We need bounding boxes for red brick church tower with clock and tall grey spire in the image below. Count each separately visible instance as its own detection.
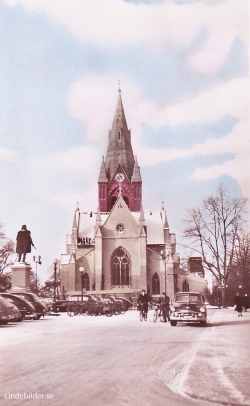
[98,88,142,212]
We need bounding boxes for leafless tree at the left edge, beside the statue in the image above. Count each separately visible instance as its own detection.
[0,224,15,290]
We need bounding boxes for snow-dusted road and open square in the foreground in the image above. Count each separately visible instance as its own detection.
[0,309,250,406]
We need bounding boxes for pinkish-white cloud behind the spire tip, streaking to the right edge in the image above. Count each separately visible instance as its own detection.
[69,75,250,200]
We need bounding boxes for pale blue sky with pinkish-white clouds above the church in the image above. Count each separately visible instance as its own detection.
[0,0,250,281]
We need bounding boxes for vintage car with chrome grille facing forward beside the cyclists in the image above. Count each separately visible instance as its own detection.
[169,292,207,326]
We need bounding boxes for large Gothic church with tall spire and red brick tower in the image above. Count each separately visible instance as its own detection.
[60,89,188,299]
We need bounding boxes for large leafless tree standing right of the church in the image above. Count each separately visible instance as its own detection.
[184,185,246,306]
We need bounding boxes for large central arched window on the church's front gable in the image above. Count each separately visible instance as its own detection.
[111,247,130,286]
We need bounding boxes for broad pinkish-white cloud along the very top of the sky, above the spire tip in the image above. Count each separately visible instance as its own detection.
[3,0,248,75]
